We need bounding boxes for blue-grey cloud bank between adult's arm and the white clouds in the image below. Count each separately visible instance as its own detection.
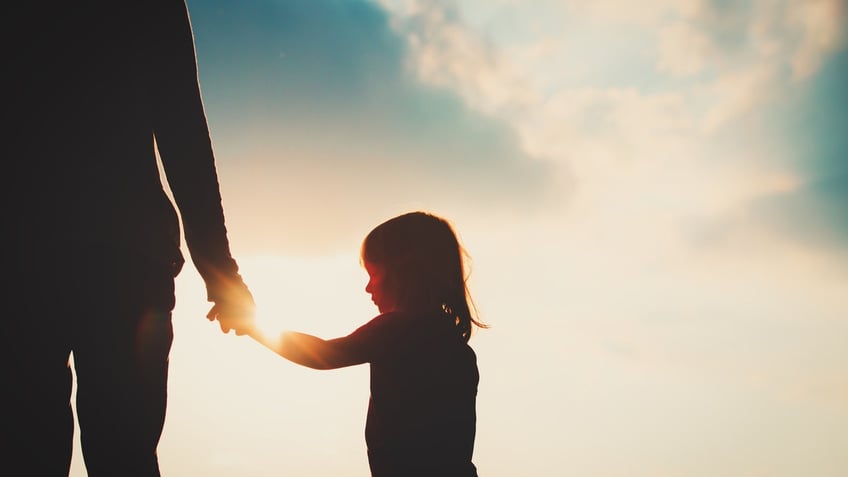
[189,0,561,253]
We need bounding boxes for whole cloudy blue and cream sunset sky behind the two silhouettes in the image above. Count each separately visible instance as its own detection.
[72,0,848,477]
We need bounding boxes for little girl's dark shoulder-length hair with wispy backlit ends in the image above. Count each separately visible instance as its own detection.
[360,212,488,341]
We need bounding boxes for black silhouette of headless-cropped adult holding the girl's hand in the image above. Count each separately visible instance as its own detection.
[2,0,254,477]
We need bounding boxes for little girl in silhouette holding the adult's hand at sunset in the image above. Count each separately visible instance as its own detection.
[245,212,487,477]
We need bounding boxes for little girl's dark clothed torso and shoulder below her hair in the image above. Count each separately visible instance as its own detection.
[332,311,480,477]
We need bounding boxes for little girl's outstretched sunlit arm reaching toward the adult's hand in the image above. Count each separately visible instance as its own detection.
[248,331,364,369]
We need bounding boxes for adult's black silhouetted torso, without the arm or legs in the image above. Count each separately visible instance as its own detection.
[10,0,184,256]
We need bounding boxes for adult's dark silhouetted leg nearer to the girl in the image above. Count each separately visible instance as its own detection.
[74,260,174,477]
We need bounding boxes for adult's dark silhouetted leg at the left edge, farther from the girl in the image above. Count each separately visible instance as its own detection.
[0,253,74,477]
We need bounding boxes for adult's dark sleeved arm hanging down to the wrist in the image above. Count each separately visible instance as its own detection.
[145,0,244,302]
